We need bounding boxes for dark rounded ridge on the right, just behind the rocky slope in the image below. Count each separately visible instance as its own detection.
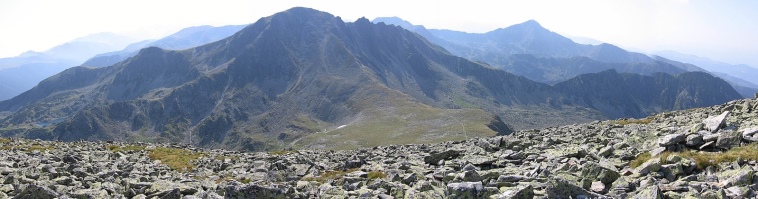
[555,70,741,118]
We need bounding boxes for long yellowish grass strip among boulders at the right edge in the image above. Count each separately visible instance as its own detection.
[629,144,758,169]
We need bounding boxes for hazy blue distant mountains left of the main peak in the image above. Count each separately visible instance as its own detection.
[0,25,244,100]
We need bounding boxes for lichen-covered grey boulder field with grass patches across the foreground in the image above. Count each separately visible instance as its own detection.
[0,96,758,198]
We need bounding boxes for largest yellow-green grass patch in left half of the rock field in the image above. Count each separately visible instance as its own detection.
[148,147,203,171]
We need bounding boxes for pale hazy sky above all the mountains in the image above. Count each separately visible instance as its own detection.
[0,0,758,66]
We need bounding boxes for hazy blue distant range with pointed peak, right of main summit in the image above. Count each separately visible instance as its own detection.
[373,17,758,97]
